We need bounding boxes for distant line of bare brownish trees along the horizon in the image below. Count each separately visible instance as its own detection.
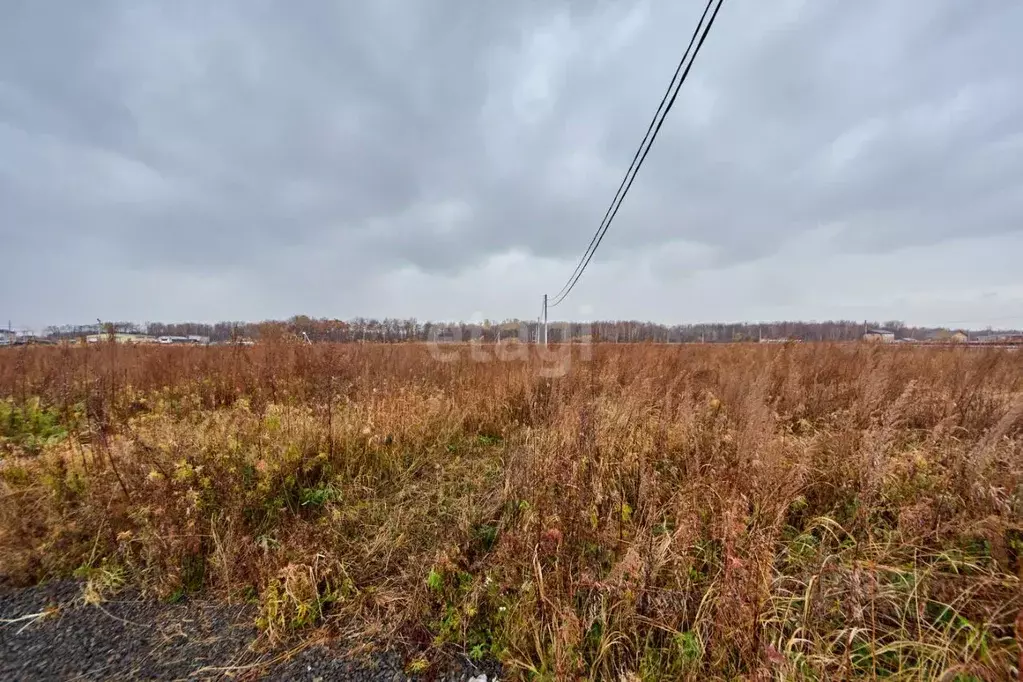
[36,315,1018,344]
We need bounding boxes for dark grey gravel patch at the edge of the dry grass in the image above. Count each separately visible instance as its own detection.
[0,582,496,682]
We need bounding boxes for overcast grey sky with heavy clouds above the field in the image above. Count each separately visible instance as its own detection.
[0,0,1023,327]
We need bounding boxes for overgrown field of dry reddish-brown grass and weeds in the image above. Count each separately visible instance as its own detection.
[0,343,1023,682]
